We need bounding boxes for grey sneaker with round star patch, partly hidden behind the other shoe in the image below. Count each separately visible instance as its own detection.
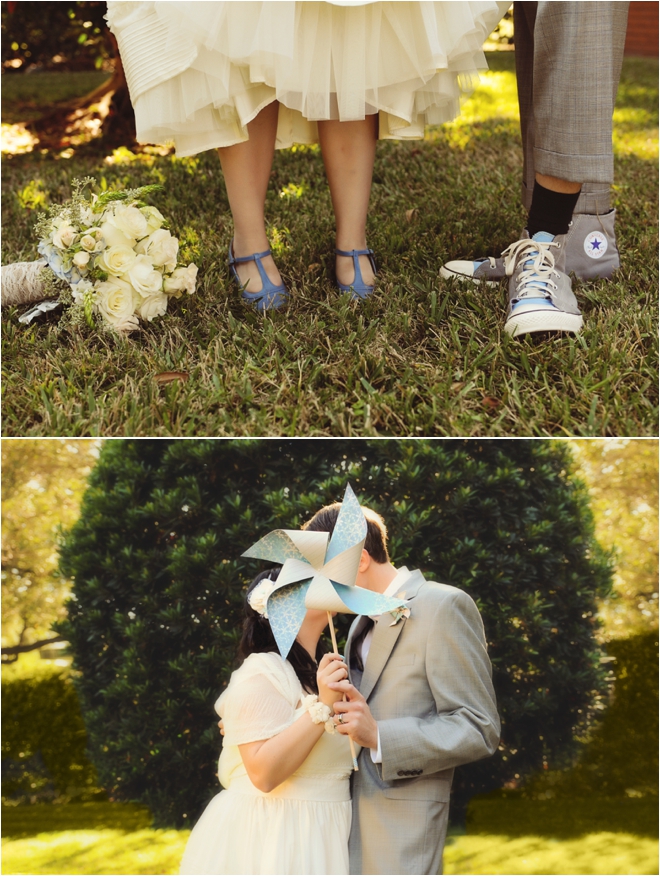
[440,210,620,286]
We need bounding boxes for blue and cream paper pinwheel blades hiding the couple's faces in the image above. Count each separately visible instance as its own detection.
[243,485,405,659]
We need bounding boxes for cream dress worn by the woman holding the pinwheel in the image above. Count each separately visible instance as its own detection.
[180,653,351,876]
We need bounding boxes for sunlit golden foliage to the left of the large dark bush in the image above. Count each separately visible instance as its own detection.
[2,438,98,646]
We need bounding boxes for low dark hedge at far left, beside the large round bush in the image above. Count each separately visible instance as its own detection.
[2,666,97,802]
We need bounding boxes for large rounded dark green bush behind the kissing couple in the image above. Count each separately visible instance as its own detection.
[59,439,611,825]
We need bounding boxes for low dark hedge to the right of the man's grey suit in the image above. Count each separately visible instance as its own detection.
[466,630,658,824]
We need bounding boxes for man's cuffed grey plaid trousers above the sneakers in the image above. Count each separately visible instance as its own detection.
[513,2,629,213]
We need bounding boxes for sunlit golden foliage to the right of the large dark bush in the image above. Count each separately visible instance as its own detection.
[571,439,658,638]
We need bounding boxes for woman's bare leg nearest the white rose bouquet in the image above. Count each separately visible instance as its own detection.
[218,100,282,292]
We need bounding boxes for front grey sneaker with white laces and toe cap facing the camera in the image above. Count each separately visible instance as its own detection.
[502,231,582,338]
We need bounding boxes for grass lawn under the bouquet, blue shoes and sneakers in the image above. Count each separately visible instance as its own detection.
[2,53,658,436]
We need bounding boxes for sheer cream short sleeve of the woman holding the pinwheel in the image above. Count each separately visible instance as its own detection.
[216,654,299,745]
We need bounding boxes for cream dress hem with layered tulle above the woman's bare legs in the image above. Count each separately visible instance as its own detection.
[107,0,509,156]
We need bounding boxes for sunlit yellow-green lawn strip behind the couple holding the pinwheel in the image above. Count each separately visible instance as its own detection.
[2,801,658,876]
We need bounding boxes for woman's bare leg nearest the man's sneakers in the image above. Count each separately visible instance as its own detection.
[318,115,378,286]
